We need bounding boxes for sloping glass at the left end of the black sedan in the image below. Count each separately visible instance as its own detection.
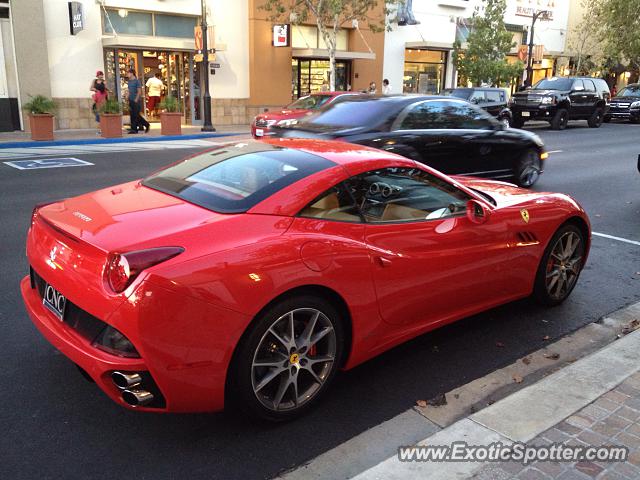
[298,98,400,127]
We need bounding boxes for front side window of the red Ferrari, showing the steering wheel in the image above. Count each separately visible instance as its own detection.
[348,167,469,223]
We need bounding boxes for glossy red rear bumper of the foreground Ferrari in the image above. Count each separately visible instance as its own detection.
[20,276,244,412]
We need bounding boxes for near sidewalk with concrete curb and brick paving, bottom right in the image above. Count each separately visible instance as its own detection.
[281,303,640,480]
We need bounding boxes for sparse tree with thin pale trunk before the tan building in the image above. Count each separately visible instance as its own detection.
[261,0,398,92]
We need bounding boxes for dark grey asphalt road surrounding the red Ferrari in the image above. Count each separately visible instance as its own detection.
[0,122,640,479]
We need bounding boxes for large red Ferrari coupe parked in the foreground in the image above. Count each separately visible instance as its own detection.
[21,139,590,420]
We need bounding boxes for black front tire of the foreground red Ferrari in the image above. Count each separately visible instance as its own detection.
[533,223,586,306]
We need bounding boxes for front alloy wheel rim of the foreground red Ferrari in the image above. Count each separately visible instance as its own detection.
[545,231,584,300]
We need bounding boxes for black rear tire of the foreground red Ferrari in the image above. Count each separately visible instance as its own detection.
[227,295,345,422]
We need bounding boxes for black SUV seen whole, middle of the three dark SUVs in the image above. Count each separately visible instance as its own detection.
[510,77,611,130]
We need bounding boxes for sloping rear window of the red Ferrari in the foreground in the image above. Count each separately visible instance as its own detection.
[142,143,335,213]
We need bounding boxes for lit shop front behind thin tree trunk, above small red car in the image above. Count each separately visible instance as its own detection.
[291,58,351,100]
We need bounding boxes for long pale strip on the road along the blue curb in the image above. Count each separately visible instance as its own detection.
[0,139,218,160]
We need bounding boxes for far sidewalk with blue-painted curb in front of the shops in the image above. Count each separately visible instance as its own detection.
[0,123,251,148]
